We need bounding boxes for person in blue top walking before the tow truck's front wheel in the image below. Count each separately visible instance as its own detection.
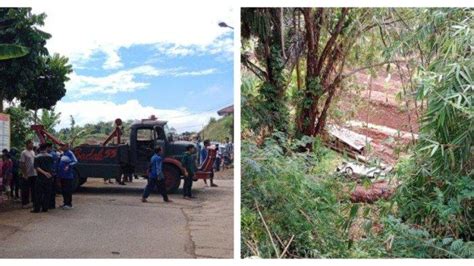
[142,146,172,202]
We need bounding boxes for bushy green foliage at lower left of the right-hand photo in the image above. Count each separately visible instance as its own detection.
[241,133,349,257]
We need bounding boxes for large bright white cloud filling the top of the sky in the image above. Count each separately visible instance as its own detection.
[32,0,235,69]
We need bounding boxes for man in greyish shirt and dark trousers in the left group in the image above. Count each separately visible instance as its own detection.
[20,139,36,209]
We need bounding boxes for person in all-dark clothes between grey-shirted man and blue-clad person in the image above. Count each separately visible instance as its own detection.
[31,143,54,213]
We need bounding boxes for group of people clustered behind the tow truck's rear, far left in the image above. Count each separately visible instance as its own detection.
[0,140,77,213]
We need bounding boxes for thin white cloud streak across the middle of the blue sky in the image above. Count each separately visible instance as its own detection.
[66,65,216,98]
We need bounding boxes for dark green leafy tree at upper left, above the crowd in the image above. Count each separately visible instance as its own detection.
[0,8,72,113]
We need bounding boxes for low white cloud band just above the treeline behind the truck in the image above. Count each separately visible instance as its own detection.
[56,100,218,132]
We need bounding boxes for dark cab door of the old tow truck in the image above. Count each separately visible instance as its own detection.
[135,128,155,173]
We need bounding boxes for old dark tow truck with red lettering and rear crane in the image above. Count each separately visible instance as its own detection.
[31,116,216,193]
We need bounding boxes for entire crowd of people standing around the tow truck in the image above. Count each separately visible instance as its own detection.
[0,138,234,208]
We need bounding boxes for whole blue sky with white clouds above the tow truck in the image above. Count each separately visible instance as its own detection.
[32,0,235,132]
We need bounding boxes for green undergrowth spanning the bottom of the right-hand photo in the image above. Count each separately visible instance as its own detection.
[241,132,474,258]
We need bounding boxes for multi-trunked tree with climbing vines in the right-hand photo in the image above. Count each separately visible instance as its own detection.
[241,8,430,140]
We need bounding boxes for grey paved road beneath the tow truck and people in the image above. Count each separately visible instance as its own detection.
[0,170,233,258]
